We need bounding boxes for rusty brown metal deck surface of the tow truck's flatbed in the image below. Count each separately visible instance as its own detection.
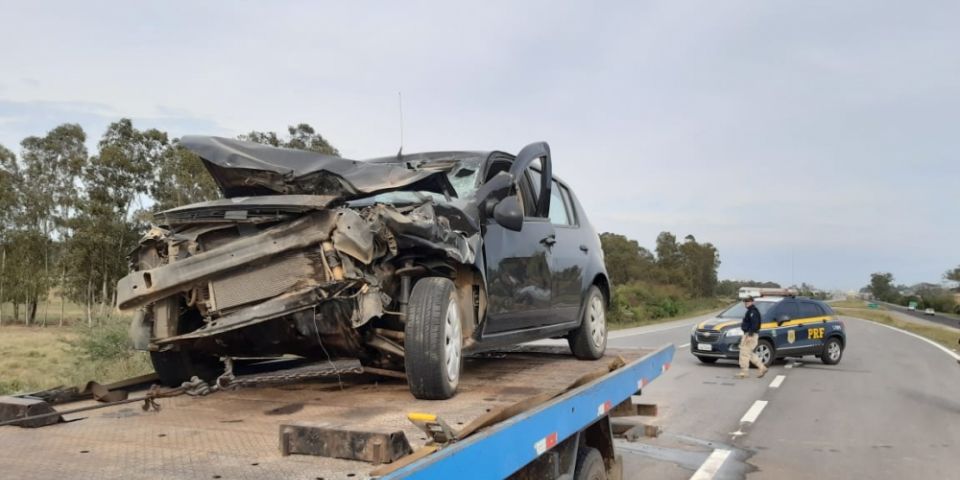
[0,346,673,480]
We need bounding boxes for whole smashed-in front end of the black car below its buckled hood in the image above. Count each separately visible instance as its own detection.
[118,200,479,372]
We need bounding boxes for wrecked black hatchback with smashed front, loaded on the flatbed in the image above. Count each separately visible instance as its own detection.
[117,136,610,399]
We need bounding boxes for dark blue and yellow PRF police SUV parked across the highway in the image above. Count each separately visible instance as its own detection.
[690,289,847,366]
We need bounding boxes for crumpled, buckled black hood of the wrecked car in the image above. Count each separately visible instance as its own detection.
[180,135,456,200]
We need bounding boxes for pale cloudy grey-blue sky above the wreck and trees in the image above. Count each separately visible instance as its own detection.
[0,0,960,289]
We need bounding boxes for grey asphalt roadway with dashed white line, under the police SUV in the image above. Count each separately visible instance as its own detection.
[609,310,960,480]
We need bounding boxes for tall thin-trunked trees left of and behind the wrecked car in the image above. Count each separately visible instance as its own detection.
[0,118,339,325]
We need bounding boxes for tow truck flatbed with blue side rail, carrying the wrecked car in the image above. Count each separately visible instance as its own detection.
[0,345,674,480]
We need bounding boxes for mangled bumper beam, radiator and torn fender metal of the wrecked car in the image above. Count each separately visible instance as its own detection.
[117,202,479,346]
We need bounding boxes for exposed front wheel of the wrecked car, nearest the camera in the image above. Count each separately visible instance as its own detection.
[404,277,463,400]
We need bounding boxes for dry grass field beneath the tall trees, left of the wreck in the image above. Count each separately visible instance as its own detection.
[0,318,153,394]
